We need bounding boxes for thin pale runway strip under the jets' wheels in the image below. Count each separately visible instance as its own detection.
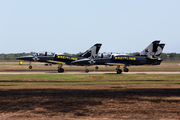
[0,72,180,75]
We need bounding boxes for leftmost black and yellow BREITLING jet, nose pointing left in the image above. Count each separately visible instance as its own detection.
[16,43,102,73]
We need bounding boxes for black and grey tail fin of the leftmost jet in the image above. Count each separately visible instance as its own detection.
[80,43,102,58]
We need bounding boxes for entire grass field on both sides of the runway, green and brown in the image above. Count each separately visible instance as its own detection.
[0,62,180,120]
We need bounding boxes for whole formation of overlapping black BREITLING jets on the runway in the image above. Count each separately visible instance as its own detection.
[16,41,165,74]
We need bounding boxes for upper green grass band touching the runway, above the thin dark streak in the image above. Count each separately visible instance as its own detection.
[0,74,180,81]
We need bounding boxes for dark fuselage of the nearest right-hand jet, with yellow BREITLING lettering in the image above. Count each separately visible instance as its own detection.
[72,55,162,66]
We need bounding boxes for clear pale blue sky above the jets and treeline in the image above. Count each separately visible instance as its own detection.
[0,0,180,54]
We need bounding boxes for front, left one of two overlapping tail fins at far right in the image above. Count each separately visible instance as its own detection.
[140,41,160,58]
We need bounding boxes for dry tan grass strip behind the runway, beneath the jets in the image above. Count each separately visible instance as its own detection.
[0,61,180,72]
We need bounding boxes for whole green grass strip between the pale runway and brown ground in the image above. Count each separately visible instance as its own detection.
[0,74,180,85]
